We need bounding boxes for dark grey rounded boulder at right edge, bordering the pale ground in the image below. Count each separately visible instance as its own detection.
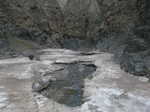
[121,47,150,77]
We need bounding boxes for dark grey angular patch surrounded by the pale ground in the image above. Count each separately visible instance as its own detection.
[33,62,96,107]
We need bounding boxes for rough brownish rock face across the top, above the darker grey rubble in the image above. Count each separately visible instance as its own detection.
[1,0,138,41]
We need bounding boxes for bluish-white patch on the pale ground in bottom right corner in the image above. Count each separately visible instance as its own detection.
[81,88,150,112]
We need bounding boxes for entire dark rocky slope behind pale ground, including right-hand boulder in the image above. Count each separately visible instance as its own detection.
[0,0,150,76]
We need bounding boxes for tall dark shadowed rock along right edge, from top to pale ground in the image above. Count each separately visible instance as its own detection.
[121,0,150,77]
